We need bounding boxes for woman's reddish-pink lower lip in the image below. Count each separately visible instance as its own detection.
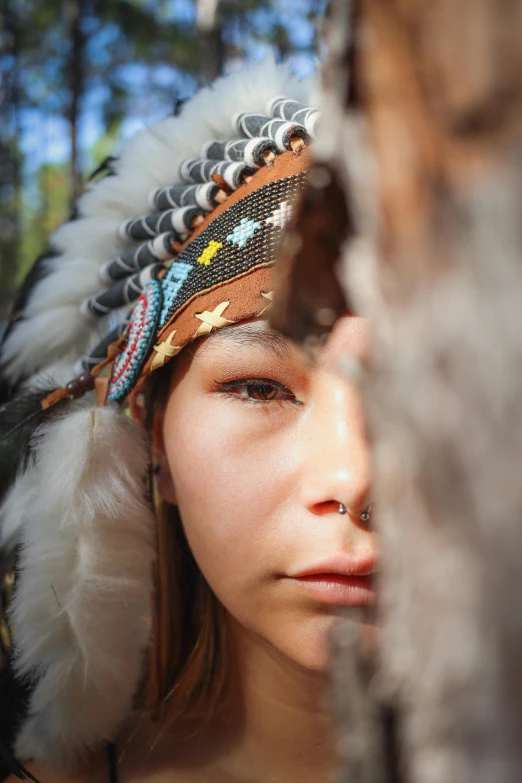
[284,574,376,606]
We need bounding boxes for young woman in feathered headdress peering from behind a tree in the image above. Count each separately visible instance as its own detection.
[0,58,377,783]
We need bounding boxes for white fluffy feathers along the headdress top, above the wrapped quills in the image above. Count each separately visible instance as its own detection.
[2,57,308,383]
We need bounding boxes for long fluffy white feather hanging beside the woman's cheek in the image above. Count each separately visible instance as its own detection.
[8,406,155,764]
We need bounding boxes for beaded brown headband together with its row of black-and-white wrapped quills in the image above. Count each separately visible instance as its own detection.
[4,97,319,409]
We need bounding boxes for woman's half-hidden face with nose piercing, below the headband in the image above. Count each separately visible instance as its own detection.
[156,317,377,670]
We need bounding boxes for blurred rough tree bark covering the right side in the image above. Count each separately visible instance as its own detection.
[276,0,522,783]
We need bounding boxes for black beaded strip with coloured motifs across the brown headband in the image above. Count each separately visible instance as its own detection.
[159,172,306,328]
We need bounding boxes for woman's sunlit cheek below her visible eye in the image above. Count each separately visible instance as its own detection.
[165,397,296,597]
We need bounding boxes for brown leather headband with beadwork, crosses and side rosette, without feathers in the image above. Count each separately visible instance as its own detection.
[105,152,309,400]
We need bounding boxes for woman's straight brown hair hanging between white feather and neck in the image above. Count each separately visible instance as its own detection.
[140,362,229,723]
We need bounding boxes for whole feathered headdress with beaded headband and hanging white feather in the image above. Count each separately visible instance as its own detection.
[0,60,319,763]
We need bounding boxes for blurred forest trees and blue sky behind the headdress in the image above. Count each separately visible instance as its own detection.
[0,0,326,326]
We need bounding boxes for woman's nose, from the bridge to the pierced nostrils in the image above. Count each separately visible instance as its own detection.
[300,370,372,519]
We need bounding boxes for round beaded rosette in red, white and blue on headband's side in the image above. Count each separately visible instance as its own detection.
[107,280,162,402]
